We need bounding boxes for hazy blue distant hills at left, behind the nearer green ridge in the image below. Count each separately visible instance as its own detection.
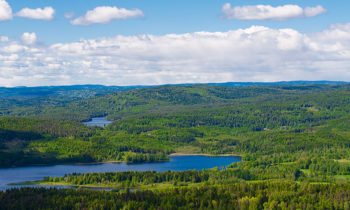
[0,85,139,120]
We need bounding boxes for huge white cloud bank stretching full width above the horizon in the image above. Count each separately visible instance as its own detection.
[0,23,350,86]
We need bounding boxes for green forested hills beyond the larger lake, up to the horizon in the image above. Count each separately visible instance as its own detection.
[0,84,350,173]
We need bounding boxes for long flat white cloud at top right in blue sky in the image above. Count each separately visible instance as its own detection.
[222,3,327,20]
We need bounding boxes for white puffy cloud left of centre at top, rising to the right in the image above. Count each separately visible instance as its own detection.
[70,6,144,26]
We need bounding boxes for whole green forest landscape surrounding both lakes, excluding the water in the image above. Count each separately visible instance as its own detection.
[0,84,350,209]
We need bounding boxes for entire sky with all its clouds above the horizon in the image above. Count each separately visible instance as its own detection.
[0,0,350,87]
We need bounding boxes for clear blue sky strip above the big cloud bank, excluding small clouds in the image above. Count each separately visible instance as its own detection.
[0,0,350,44]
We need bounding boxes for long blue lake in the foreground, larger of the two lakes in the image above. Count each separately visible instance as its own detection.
[0,156,241,190]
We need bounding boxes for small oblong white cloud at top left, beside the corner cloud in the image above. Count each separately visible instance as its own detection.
[16,7,55,20]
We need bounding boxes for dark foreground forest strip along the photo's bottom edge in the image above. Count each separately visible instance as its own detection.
[0,182,350,209]
